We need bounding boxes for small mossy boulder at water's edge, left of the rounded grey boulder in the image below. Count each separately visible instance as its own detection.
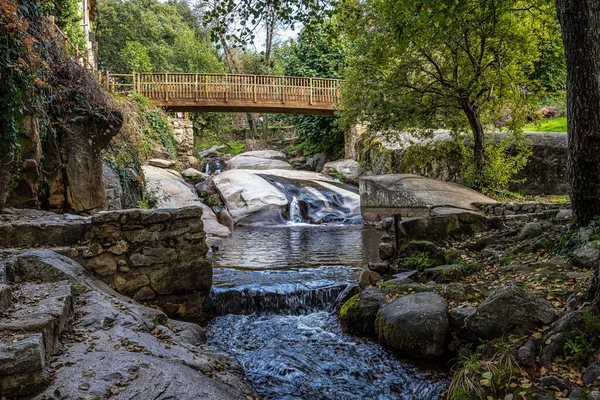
[340,287,385,335]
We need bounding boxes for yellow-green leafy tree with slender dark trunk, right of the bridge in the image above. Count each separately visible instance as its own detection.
[342,0,547,171]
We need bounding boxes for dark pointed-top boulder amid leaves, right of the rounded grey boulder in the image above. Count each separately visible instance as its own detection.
[465,286,556,339]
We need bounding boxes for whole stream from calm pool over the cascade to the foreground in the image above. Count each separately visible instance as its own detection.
[207,224,444,400]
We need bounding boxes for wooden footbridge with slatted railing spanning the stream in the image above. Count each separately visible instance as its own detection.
[99,72,342,115]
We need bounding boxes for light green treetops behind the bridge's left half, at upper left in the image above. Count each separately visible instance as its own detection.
[96,0,225,73]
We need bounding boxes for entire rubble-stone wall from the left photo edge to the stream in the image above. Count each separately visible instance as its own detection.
[0,206,212,319]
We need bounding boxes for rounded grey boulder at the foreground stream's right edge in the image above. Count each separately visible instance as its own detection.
[375,292,450,357]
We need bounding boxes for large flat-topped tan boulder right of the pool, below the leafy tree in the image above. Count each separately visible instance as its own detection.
[359,174,496,221]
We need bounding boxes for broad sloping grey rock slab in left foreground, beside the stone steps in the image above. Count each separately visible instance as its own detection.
[38,290,255,400]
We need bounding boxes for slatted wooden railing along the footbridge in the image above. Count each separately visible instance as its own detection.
[104,72,342,105]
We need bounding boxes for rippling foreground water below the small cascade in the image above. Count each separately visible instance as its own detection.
[209,311,442,400]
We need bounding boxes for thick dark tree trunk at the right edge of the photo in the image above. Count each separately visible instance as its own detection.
[556,0,600,226]
